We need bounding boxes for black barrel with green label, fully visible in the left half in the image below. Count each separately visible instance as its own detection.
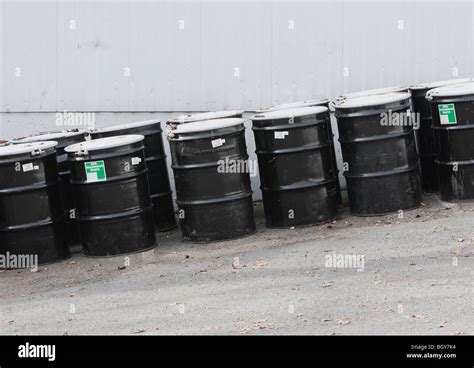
[66,135,156,257]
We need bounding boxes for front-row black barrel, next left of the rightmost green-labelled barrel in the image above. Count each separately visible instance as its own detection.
[334,93,421,216]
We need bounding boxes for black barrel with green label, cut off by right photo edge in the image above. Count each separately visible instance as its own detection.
[426,83,474,201]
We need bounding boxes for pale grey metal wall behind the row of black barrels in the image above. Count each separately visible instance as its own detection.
[0,0,474,197]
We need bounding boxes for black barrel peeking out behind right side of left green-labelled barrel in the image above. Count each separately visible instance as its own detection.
[91,120,176,231]
